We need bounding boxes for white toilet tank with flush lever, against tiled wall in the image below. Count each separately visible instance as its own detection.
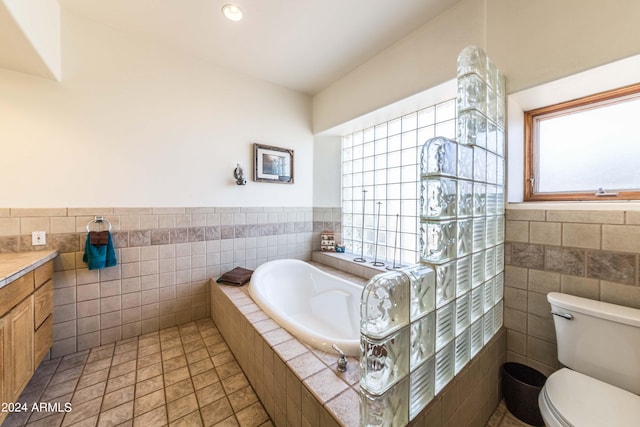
[547,292,640,394]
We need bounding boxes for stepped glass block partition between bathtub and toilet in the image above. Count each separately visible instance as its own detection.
[360,46,505,426]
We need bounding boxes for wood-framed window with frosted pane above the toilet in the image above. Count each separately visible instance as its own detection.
[524,84,640,201]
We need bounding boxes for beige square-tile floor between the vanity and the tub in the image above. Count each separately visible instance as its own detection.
[2,319,272,427]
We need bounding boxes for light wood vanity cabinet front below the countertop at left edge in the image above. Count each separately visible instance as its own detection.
[0,261,53,423]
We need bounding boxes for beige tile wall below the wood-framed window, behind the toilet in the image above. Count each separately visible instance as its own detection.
[504,206,640,375]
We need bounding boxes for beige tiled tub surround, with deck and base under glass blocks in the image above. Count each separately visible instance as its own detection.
[210,260,506,427]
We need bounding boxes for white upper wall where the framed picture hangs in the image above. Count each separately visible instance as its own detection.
[0,11,313,207]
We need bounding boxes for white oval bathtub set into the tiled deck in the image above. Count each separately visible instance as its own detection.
[249,259,362,356]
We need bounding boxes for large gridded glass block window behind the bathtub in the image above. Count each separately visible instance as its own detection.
[342,99,456,265]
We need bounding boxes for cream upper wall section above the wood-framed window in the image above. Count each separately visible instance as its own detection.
[486,0,640,93]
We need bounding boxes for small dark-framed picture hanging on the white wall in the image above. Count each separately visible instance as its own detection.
[253,144,293,184]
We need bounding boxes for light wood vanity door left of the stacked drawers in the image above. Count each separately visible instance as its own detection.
[4,295,33,402]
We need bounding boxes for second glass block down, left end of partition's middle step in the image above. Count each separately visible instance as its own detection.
[420,177,458,219]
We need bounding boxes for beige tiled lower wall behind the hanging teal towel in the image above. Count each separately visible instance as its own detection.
[0,207,341,357]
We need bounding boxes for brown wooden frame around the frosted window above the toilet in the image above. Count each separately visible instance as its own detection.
[524,83,640,202]
